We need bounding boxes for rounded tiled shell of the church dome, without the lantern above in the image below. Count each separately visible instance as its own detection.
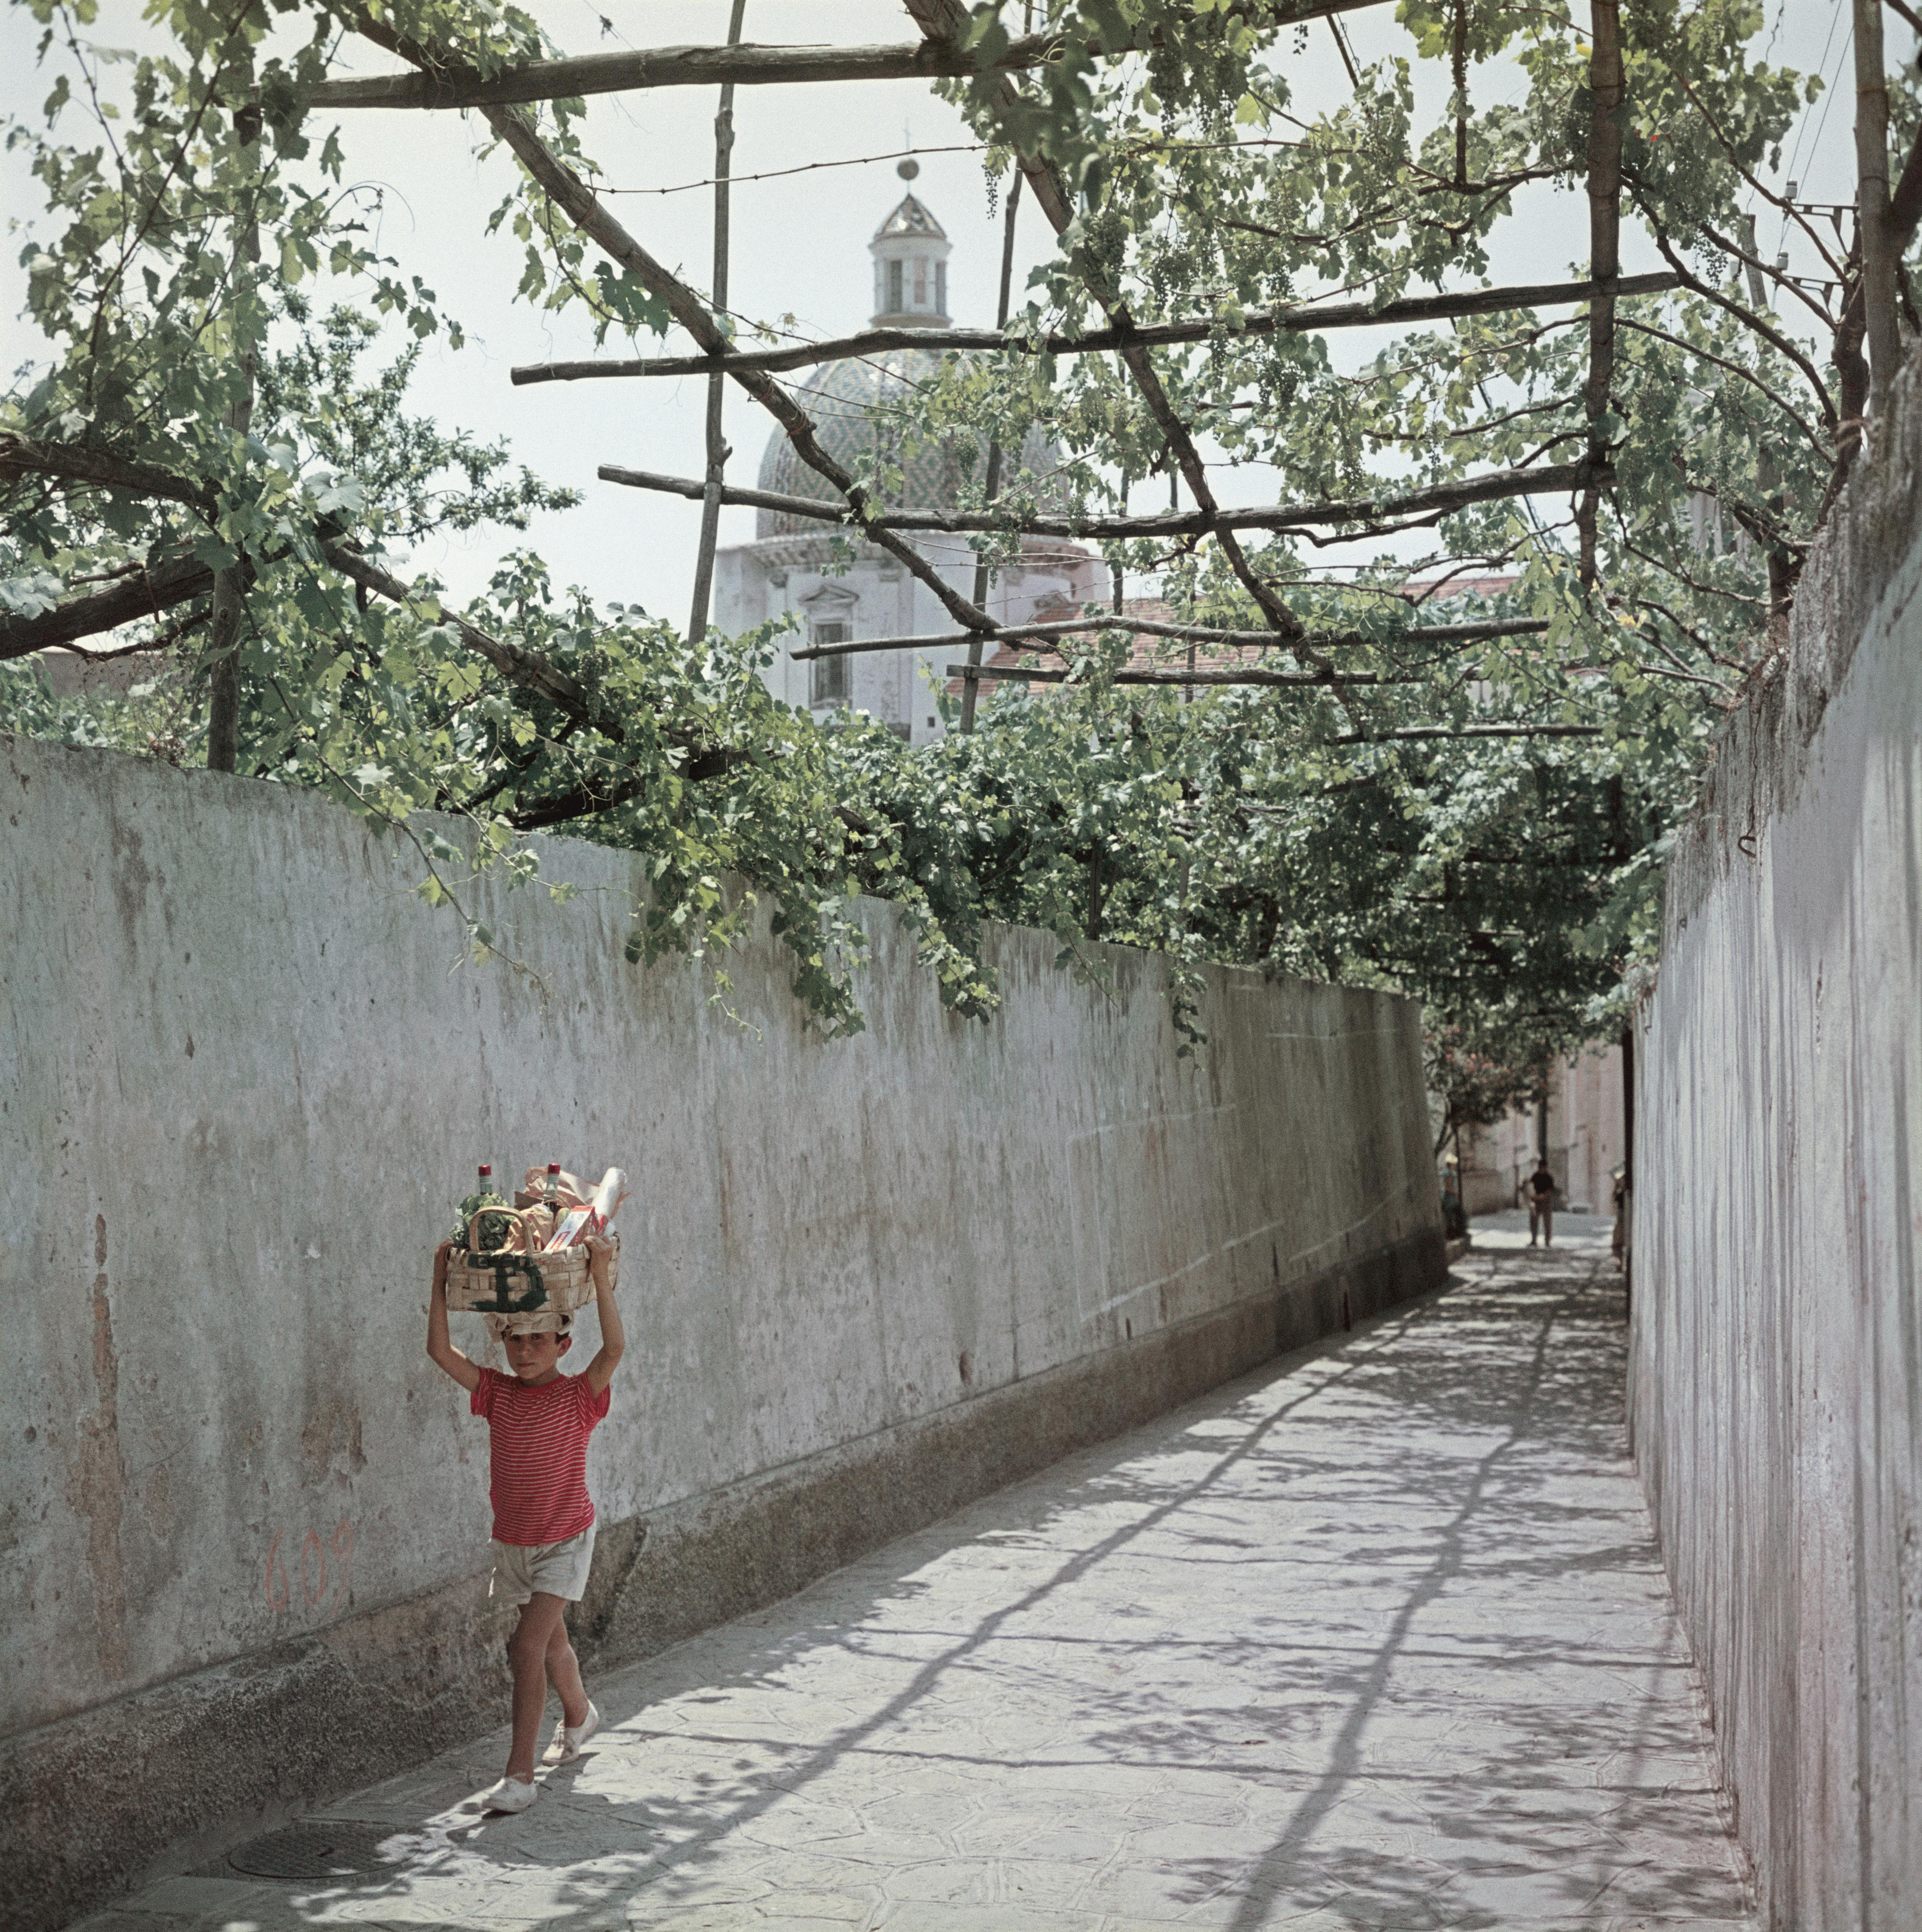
[755,350,1061,537]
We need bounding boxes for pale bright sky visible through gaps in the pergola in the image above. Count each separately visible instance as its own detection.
[0,0,1862,622]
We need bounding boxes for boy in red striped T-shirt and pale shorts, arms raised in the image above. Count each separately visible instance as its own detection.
[427,1241,626,1812]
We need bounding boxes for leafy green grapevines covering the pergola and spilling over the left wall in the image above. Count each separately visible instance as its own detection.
[0,0,1877,1074]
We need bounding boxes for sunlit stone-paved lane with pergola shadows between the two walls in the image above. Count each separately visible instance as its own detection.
[87,1217,1746,1932]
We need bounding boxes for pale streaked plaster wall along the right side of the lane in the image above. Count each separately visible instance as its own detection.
[1631,355,1922,1932]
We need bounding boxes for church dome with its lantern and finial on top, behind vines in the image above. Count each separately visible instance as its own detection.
[755,160,1061,537]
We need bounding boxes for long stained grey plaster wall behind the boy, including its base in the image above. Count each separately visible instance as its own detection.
[0,740,1441,1924]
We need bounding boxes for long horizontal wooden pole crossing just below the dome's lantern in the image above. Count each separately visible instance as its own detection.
[510,268,1681,385]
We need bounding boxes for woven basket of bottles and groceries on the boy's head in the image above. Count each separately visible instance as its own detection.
[446,1161,626,1316]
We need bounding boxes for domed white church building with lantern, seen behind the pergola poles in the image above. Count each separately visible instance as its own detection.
[715,160,1099,744]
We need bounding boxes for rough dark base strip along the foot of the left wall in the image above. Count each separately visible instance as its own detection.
[0,1231,1447,1932]
